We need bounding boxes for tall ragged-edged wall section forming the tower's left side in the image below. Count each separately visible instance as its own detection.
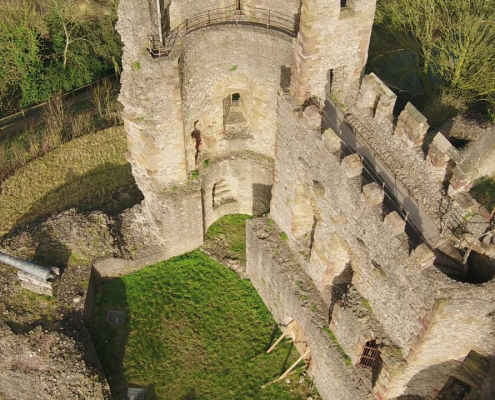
[117,0,187,191]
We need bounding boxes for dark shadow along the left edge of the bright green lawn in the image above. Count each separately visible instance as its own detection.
[89,278,131,400]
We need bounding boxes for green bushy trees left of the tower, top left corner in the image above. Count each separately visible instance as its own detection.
[0,0,122,111]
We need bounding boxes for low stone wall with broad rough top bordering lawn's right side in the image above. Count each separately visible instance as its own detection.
[246,219,374,400]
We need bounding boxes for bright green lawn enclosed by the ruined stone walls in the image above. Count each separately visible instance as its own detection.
[91,250,312,400]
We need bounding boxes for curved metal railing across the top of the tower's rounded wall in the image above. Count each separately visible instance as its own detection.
[148,5,299,57]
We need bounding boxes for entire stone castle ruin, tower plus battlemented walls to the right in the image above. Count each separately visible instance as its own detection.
[115,0,495,400]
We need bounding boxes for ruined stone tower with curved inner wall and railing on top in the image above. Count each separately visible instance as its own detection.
[117,0,375,256]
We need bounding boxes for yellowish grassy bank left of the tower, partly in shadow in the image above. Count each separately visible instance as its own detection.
[0,127,142,236]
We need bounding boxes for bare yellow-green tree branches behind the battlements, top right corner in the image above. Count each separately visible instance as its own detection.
[370,0,495,115]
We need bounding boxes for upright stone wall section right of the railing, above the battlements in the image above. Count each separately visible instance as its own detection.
[291,0,376,104]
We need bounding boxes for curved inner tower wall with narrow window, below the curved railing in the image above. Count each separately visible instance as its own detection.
[181,26,292,170]
